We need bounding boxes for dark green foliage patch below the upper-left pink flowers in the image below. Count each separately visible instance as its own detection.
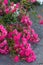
[2,14,17,24]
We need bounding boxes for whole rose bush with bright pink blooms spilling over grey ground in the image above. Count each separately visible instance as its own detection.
[0,0,40,62]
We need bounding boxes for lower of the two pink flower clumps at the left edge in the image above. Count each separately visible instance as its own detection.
[0,40,9,54]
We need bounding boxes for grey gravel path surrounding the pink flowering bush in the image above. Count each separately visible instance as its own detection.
[0,5,43,65]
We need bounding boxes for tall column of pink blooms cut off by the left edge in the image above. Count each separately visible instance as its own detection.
[0,25,8,54]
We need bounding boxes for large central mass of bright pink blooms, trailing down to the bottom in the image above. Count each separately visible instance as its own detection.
[8,16,39,62]
